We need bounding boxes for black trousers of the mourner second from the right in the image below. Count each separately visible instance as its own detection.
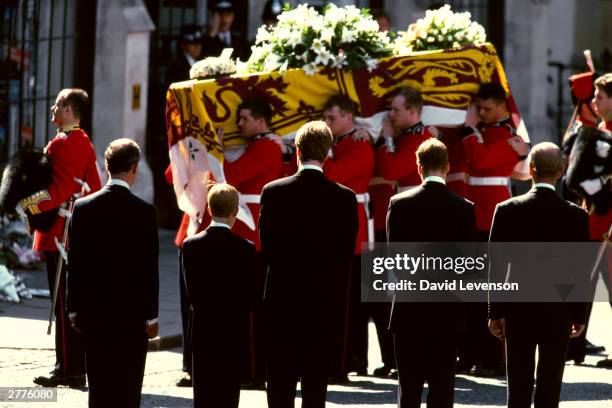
[393,331,457,408]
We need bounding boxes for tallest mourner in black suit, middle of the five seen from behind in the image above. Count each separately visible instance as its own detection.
[259,122,358,408]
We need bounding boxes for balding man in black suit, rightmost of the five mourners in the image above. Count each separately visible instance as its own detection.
[489,142,589,408]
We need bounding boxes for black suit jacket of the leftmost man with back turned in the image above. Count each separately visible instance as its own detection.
[66,185,159,328]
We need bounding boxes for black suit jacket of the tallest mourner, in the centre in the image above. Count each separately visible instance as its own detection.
[259,169,358,324]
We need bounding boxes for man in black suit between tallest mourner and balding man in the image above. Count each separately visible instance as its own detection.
[387,138,476,408]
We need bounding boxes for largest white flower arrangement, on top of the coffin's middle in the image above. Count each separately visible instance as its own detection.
[246,4,392,75]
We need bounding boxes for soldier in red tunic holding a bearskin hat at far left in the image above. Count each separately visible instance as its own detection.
[21,89,100,387]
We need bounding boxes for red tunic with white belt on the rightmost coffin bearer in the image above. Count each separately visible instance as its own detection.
[463,119,519,231]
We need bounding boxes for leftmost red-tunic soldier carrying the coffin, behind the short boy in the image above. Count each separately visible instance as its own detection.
[220,99,282,389]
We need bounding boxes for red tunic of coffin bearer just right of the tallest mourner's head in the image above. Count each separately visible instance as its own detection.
[323,130,374,254]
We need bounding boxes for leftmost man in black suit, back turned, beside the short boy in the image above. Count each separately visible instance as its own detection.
[67,139,159,407]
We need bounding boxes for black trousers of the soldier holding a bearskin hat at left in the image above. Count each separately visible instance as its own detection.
[45,251,85,375]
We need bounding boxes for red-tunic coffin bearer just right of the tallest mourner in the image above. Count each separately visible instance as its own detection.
[323,95,374,382]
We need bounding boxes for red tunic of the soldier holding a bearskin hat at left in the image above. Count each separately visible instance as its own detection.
[33,128,100,251]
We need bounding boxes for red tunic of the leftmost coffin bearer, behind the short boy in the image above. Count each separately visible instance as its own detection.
[223,134,283,251]
